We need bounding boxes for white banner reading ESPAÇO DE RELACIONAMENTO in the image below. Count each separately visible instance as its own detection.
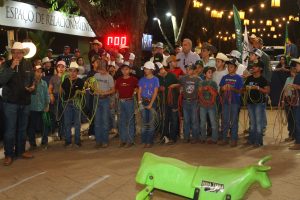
[0,1,96,37]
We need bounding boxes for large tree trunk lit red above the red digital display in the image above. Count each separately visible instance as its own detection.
[41,0,147,64]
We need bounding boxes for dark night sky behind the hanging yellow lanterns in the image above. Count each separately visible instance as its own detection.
[146,0,300,51]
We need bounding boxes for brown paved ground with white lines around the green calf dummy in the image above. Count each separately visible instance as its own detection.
[0,111,300,200]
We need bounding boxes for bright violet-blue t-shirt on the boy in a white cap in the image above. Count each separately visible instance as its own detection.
[139,76,159,99]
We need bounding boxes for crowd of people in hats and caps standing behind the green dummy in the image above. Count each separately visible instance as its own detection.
[0,36,300,166]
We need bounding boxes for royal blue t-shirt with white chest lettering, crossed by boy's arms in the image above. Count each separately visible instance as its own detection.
[219,74,243,104]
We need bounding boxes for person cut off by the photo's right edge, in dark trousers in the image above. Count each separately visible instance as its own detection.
[289,58,300,150]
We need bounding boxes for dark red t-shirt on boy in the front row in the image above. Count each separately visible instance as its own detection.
[116,76,138,99]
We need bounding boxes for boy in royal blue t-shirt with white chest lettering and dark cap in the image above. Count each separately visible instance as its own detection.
[219,59,243,147]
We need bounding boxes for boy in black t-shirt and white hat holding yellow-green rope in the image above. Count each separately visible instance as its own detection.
[61,62,84,148]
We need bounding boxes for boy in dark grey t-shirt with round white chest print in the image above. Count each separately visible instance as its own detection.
[179,64,200,144]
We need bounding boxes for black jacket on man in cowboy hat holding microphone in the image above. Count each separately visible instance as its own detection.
[0,59,34,105]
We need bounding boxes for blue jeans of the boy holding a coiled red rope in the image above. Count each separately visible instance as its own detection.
[200,106,218,142]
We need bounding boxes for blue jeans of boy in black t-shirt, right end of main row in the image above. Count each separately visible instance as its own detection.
[247,103,266,145]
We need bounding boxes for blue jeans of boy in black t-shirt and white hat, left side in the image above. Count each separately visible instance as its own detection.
[64,102,81,144]
